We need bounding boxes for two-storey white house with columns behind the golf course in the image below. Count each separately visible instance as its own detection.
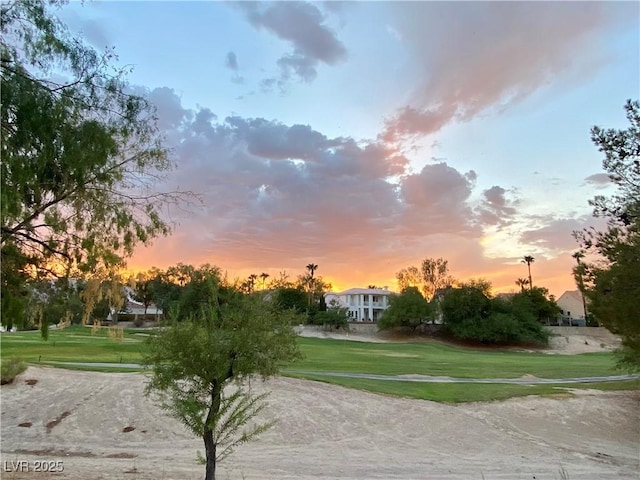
[325,287,394,322]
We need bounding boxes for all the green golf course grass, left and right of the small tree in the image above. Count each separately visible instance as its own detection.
[0,327,640,403]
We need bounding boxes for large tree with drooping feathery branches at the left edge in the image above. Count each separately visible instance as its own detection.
[0,0,183,330]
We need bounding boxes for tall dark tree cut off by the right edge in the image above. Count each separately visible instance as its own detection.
[574,100,640,370]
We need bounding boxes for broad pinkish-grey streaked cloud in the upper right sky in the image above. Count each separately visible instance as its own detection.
[385,2,637,140]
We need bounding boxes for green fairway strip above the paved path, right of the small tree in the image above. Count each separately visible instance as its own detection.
[287,338,621,378]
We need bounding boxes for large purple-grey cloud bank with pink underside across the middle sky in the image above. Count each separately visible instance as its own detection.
[138,88,506,281]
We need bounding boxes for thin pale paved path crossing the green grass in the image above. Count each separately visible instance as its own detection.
[285,370,640,385]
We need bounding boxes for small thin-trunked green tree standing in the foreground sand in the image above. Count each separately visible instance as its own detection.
[145,275,300,480]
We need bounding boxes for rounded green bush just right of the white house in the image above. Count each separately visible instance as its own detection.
[378,287,433,330]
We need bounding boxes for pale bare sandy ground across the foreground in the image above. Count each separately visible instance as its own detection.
[1,367,640,480]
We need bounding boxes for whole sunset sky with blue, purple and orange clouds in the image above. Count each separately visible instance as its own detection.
[58,1,640,296]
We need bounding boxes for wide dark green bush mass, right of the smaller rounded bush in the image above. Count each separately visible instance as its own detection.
[440,284,557,344]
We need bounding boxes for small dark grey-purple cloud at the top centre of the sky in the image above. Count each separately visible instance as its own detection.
[236,2,347,83]
